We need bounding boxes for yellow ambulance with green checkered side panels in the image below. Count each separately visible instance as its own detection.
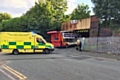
[0,32,54,54]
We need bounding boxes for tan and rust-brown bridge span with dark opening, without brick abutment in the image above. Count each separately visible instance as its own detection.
[61,18,91,37]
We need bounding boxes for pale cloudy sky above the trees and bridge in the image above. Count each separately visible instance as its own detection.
[0,0,94,17]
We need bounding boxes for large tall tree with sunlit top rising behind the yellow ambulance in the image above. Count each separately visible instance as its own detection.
[23,0,69,36]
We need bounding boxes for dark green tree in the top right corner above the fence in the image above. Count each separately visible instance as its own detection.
[91,0,120,29]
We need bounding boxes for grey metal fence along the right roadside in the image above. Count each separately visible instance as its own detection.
[83,37,120,54]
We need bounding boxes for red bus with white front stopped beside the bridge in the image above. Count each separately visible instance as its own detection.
[47,31,76,47]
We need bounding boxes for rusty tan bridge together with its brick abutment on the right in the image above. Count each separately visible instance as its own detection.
[61,15,111,37]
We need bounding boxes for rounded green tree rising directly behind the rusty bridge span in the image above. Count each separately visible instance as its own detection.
[71,4,91,20]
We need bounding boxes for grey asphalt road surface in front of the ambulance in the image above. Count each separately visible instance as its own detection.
[0,48,120,80]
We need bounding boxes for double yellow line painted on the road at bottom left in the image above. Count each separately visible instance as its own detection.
[2,65,27,80]
